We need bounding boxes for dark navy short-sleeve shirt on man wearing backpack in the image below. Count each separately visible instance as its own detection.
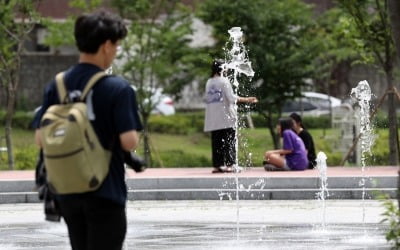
[33,63,142,205]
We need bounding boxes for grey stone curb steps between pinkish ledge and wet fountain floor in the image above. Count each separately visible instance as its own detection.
[0,176,398,204]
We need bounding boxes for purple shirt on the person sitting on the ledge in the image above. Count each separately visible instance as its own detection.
[283,129,308,170]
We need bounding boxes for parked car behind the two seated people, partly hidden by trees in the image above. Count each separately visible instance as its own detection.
[282,92,342,116]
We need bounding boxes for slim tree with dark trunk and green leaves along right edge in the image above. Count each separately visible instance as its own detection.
[338,0,399,166]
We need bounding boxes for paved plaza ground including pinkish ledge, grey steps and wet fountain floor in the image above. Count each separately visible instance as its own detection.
[0,167,398,250]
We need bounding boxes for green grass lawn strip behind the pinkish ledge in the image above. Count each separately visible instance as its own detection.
[0,128,394,170]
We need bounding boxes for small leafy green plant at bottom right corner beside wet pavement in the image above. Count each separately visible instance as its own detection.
[381,197,400,249]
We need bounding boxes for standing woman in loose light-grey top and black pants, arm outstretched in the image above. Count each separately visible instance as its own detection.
[204,59,258,173]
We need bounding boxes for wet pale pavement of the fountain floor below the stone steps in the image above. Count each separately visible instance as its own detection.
[0,200,390,250]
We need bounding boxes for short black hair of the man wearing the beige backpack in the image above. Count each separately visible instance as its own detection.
[74,10,127,54]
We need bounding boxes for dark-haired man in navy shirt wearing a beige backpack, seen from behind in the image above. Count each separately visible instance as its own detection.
[34,11,142,250]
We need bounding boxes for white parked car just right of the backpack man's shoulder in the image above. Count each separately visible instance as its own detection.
[131,85,175,115]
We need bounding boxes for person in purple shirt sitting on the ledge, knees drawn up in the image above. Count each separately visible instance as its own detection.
[264,118,308,171]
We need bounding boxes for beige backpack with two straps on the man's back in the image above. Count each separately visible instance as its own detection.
[40,72,111,194]
